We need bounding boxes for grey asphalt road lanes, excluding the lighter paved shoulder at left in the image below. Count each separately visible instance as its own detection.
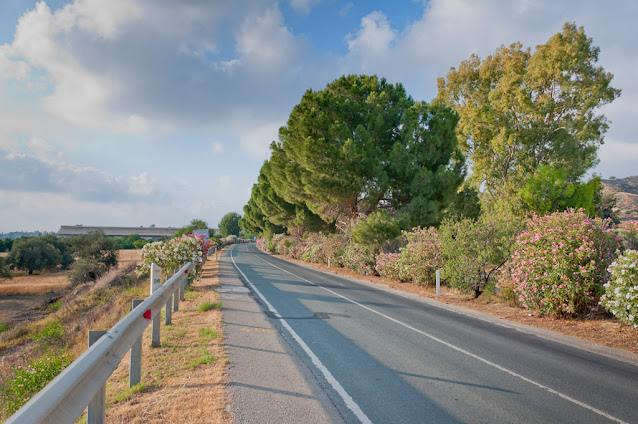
[223,245,638,423]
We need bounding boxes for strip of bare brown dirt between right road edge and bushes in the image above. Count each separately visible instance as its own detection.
[273,255,638,353]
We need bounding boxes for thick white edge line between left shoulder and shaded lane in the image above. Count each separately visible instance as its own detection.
[230,246,372,424]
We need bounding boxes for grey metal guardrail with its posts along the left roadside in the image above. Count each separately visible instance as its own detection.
[5,262,195,424]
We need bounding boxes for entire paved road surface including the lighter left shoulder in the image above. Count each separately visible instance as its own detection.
[220,244,638,424]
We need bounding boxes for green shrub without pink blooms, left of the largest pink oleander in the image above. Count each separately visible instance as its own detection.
[439,208,522,298]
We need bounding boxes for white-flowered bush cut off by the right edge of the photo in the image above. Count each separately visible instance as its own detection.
[600,250,638,329]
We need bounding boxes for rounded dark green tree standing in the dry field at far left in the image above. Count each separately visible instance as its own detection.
[9,237,62,275]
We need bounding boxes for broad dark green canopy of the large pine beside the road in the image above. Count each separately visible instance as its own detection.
[262,75,464,231]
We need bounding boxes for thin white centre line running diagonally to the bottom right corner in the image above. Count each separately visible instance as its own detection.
[249,245,629,424]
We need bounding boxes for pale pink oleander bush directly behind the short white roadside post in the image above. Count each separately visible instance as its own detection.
[375,227,441,285]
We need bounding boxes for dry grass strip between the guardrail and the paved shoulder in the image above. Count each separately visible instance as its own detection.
[99,255,230,423]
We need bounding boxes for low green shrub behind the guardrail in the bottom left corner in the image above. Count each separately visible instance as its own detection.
[0,350,71,417]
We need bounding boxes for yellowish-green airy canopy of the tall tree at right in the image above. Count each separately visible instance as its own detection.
[436,24,620,200]
